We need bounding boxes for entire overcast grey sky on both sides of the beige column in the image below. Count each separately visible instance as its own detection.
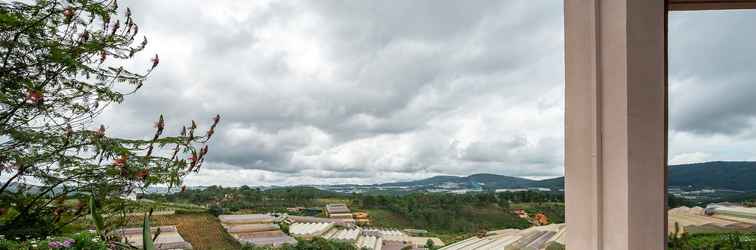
[96,0,756,186]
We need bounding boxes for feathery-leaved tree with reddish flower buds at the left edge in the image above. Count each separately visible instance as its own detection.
[0,0,220,237]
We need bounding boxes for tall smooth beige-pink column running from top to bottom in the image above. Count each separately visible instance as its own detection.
[564,0,666,250]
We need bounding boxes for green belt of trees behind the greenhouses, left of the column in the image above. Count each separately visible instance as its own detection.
[151,186,564,233]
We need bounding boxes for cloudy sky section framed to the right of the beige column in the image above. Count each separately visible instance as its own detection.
[669,11,756,164]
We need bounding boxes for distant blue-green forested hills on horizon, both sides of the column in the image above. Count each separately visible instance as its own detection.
[381,161,756,191]
